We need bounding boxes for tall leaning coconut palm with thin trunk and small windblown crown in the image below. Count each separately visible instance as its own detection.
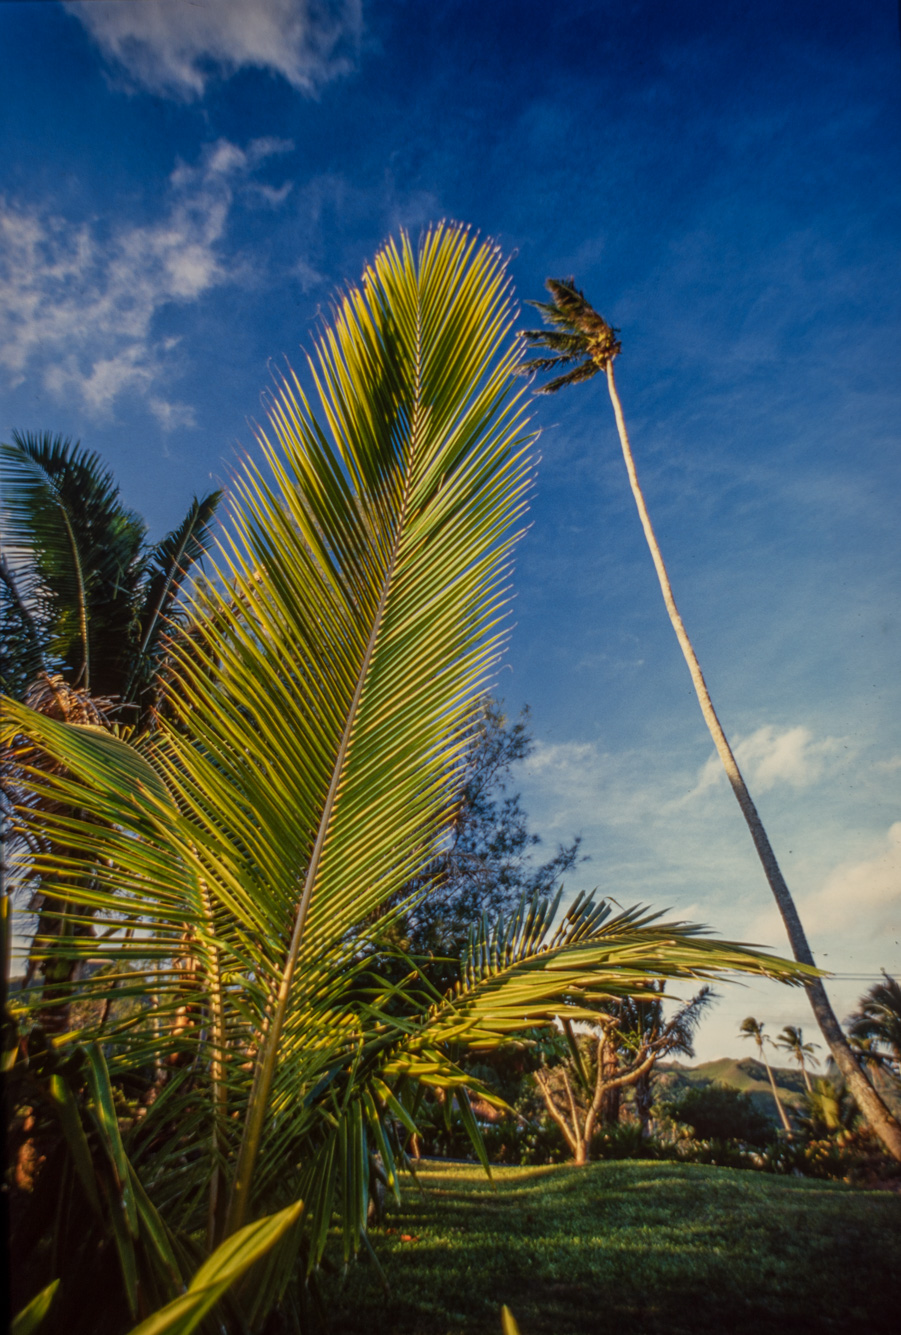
[521,278,901,1160]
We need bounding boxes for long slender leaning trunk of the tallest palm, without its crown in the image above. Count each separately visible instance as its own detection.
[603,359,901,1161]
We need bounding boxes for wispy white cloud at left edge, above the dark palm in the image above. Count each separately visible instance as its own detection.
[0,139,291,430]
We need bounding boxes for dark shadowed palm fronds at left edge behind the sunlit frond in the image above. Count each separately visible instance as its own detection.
[0,431,222,730]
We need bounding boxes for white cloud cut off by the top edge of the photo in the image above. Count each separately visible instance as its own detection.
[65,0,362,99]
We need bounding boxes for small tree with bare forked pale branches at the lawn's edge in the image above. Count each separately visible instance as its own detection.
[534,981,711,1164]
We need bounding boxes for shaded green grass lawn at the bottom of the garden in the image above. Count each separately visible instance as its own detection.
[331,1161,901,1335]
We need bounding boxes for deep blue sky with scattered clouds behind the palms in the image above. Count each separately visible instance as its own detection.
[0,0,901,1057]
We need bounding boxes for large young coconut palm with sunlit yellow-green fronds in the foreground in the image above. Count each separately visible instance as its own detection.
[7,226,809,1335]
